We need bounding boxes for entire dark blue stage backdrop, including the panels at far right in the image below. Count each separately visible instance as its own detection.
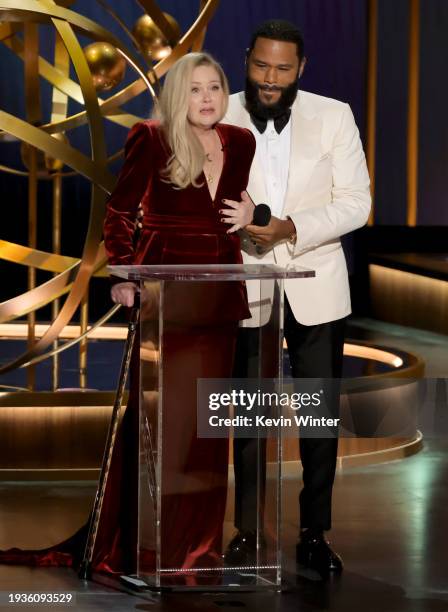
[0,0,448,268]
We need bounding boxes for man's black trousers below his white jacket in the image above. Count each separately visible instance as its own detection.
[234,297,346,530]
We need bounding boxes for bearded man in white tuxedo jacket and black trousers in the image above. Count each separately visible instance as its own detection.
[224,20,371,576]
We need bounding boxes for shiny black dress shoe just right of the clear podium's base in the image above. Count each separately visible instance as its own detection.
[296,529,344,578]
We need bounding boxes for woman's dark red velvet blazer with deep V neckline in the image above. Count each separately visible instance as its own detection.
[104,120,255,319]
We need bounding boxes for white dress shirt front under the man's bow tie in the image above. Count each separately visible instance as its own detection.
[249,118,291,219]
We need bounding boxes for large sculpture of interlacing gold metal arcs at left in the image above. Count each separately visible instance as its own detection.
[0,0,219,373]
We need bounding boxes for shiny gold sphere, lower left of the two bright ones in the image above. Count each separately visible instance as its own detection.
[84,42,126,91]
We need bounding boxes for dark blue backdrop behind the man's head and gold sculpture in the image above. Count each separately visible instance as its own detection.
[0,0,367,310]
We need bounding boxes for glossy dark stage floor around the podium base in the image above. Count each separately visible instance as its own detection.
[0,440,448,612]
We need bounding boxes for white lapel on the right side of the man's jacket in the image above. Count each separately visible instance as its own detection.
[283,92,323,216]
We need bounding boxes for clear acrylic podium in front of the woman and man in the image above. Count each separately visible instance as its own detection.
[109,264,314,590]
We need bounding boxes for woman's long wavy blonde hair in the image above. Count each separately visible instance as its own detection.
[156,52,229,189]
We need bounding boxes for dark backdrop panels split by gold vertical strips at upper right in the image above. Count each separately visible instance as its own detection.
[375,0,448,226]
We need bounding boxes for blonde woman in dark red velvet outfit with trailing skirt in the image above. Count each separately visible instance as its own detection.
[0,53,255,573]
